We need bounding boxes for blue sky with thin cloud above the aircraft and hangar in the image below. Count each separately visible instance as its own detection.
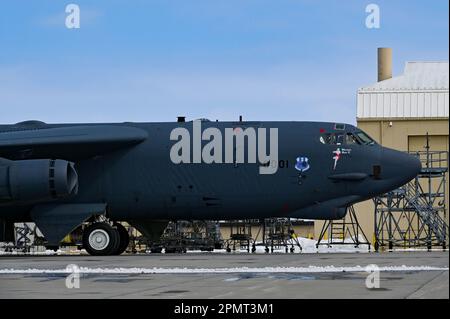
[0,0,449,123]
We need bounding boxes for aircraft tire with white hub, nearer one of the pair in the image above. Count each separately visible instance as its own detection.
[83,222,120,256]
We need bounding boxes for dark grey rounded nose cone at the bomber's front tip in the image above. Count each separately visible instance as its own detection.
[382,148,422,186]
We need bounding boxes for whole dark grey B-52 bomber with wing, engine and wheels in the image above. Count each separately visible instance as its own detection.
[0,118,421,255]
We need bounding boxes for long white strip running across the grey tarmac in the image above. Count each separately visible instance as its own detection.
[0,264,449,275]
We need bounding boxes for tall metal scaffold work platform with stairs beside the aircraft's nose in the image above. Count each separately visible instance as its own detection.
[374,149,448,251]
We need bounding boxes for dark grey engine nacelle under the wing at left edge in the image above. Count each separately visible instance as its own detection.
[0,159,78,203]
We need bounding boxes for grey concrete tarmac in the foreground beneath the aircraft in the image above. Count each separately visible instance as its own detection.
[0,252,449,299]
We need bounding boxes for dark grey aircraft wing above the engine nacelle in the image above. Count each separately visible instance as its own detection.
[0,124,148,161]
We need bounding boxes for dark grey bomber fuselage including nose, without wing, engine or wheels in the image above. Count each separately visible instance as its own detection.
[0,121,420,221]
